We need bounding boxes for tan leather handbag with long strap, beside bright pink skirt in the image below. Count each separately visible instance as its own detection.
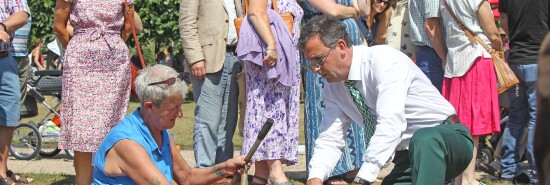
[444,1,519,94]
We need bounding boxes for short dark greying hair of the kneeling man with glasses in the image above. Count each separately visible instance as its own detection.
[298,15,353,50]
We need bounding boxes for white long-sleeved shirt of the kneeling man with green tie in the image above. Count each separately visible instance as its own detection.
[308,45,455,182]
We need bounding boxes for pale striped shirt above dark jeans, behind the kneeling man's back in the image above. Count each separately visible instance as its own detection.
[409,0,439,47]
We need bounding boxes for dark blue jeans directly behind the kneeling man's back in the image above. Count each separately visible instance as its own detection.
[416,46,443,93]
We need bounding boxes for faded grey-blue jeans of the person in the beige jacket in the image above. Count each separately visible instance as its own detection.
[191,52,241,168]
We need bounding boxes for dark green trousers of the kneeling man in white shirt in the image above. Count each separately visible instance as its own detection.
[382,123,474,185]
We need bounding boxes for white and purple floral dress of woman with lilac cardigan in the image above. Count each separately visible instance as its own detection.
[237,0,303,165]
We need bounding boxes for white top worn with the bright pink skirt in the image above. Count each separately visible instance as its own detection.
[439,0,491,78]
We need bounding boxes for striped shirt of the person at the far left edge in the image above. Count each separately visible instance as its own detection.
[0,0,31,51]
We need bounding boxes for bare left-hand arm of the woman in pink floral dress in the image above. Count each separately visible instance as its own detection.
[53,0,72,48]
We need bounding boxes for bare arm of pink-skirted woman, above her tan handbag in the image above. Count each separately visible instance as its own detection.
[477,1,504,51]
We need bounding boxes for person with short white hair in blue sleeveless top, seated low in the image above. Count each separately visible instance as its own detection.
[93,65,245,185]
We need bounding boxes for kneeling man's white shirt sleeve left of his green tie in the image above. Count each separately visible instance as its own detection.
[308,89,351,181]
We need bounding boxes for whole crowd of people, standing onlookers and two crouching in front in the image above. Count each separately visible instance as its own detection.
[0,0,550,185]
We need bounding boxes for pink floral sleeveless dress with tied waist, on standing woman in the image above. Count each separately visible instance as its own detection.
[59,0,133,152]
